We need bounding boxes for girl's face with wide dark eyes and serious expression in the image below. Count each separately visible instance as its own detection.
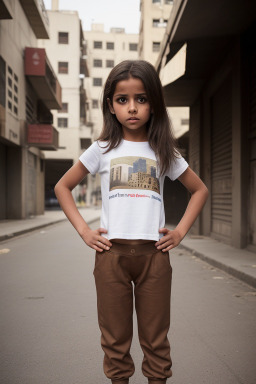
[108,77,151,138]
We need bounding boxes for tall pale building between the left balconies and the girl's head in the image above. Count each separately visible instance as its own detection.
[39,0,92,205]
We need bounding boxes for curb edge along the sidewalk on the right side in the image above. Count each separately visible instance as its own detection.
[179,244,256,288]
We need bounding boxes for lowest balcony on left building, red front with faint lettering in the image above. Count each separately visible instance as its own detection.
[27,124,59,151]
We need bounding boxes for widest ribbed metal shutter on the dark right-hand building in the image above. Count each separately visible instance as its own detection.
[211,77,232,243]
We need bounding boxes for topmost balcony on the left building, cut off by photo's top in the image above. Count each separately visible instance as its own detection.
[20,0,49,39]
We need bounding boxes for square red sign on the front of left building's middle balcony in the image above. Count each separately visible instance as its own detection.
[25,47,46,76]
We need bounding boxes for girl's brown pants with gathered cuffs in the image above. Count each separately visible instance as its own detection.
[94,242,172,384]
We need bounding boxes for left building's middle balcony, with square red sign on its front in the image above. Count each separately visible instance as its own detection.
[25,47,61,109]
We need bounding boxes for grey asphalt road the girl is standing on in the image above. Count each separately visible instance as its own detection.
[0,221,256,384]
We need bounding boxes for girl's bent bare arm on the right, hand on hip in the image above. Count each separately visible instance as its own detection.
[155,167,208,252]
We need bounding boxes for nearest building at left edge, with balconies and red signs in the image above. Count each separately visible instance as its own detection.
[0,0,61,220]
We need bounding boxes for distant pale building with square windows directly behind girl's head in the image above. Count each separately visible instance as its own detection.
[84,24,138,205]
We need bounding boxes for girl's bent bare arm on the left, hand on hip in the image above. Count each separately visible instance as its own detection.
[54,161,112,252]
